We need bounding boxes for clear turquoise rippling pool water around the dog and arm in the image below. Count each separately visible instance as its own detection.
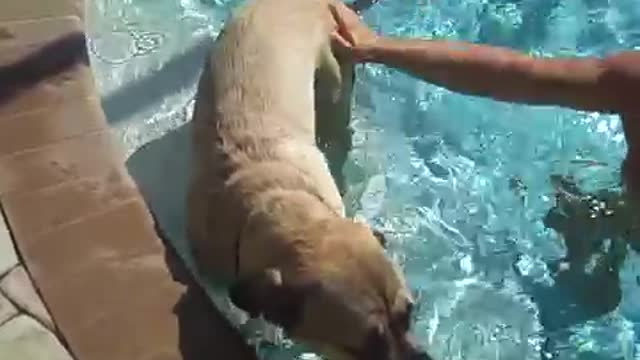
[87,0,640,360]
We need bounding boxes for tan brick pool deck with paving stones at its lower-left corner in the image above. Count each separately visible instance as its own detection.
[0,0,255,360]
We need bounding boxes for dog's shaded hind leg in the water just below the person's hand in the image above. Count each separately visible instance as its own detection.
[314,47,355,195]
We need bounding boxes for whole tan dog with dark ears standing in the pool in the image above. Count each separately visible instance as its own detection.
[188,0,429,360]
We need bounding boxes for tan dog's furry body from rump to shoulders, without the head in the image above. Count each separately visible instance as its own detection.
[189,0,353,279]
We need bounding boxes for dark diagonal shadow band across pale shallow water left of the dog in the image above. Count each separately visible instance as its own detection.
[102,36,213,124]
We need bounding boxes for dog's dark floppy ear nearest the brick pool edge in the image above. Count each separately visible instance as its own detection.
[229,269,307,330]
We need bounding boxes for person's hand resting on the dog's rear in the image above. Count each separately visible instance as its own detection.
[329,0,378,62]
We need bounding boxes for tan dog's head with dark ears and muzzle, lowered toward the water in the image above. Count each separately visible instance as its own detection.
[230,221,430,360]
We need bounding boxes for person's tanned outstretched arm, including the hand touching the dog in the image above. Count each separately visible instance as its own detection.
[332,2,640,113]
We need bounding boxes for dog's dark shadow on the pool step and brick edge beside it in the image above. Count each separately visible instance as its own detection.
[126,124,257,360]
